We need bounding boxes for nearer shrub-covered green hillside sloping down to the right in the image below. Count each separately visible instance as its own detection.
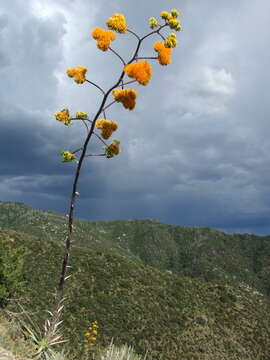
[0,228,270,360]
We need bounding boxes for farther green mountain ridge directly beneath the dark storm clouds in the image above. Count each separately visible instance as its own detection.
[0,202,270,295]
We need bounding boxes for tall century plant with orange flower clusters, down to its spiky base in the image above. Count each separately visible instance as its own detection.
[38,9,181,357]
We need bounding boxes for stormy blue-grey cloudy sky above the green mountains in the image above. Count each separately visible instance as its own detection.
[0,0,270,235]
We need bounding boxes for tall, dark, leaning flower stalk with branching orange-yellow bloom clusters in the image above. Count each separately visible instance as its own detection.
[48,10,180,354]
